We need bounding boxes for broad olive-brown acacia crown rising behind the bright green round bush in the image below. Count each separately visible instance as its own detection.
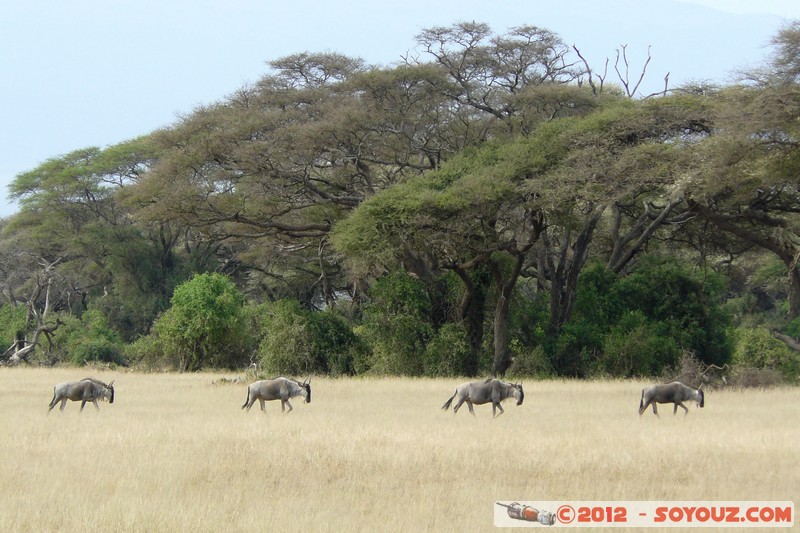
[137,54,440,305]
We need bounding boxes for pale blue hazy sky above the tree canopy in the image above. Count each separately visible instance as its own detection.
[0,0,800,216]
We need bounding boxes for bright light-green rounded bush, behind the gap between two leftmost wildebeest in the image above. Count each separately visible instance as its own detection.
[153,274,247,370]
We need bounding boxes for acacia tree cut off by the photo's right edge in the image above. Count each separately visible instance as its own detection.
[689,22,800,317]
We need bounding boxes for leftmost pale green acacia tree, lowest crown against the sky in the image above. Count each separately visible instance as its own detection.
[5,136,182,339]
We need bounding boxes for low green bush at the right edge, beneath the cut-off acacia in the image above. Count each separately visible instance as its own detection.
[733,327,800,383]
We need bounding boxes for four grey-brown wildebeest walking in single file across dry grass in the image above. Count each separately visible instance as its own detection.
[48,377,705,417]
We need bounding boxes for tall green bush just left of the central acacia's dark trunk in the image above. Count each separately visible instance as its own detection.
[359,271,434,376]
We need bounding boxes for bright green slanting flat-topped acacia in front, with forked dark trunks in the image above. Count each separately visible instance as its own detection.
[334,89,707,374]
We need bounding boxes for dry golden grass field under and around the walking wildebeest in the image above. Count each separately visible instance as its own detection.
[0,368,800,532]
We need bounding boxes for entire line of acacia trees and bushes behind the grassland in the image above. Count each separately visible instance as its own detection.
[0,22,800,381]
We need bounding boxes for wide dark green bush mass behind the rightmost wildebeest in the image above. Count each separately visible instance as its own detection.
[550,256,732,377]
